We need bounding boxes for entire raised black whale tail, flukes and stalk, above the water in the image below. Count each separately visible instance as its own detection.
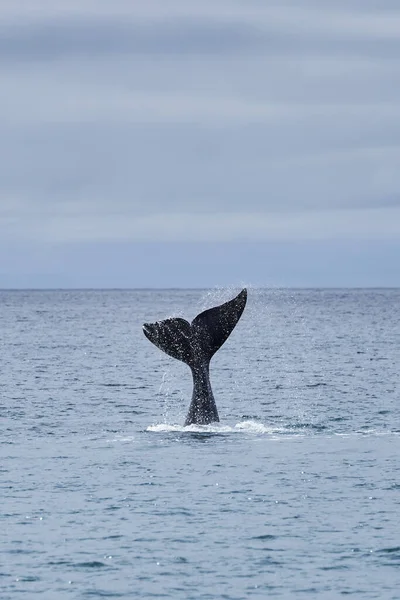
[143,289,247,425]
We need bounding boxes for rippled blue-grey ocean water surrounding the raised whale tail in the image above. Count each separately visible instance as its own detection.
[0,289,400,600]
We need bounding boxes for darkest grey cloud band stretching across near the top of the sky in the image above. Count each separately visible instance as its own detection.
[0,8,400,63]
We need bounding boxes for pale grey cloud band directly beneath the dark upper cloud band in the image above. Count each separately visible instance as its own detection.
[0,57,400,126]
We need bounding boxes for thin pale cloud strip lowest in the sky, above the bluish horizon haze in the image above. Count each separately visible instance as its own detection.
[3,207,400,243]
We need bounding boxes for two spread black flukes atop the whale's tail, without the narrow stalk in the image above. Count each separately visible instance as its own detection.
[143,288,247,367]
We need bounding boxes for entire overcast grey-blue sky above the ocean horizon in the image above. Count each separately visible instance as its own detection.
[0,0,400,288]
